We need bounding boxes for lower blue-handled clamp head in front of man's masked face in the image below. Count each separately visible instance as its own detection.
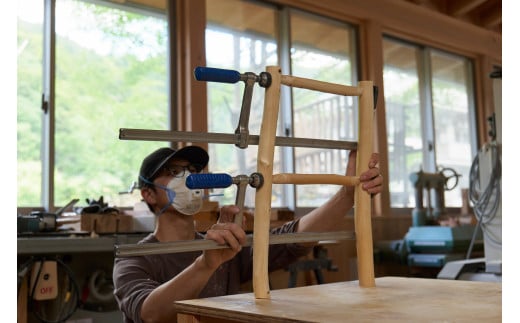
[186,173,264,225]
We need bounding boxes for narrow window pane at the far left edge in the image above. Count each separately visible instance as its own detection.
[17,0,43,206]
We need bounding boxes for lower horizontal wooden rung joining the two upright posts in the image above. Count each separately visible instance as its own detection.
[273,173,359,186]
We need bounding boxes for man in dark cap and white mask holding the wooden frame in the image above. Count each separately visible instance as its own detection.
[113,146,383,322]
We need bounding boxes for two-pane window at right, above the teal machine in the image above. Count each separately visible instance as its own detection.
[383,38,476,207]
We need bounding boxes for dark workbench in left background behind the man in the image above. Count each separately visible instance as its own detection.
[17,232,148,323]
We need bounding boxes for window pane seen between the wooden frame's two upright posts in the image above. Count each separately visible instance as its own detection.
[291,12,358,207]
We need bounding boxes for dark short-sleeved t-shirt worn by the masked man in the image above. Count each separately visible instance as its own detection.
[113,220,311,323]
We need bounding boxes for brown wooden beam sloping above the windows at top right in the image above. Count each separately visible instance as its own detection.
[272,0,502,60]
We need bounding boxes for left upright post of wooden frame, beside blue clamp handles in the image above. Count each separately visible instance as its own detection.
[253,66,281,298]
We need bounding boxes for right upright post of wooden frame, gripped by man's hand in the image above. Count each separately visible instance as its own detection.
[354,81,375,287]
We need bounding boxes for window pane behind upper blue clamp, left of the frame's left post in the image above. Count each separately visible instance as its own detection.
[206,0,281,206]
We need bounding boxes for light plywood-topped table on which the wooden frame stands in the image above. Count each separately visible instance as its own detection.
[175,277,502,323]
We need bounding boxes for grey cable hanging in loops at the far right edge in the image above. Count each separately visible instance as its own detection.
[466,141,502,259]
